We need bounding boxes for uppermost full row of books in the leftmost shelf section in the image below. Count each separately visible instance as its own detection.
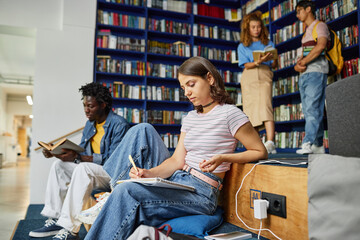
[98,9,146,29]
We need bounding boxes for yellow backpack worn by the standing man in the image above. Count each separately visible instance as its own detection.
[312,21,344,76]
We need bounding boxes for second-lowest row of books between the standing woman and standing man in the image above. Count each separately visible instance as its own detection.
[274,103,304,122]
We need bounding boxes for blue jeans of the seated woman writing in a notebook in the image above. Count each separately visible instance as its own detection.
[86,124,222,239]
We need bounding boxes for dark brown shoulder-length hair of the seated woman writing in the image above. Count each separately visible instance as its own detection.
[178,57,234,112]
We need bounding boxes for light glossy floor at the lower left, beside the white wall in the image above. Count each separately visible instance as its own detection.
[0,158,30,239]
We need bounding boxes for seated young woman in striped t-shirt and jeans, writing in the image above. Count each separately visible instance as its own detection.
[86,57,267,239]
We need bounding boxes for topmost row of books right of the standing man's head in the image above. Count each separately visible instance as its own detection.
[315,0,357,22]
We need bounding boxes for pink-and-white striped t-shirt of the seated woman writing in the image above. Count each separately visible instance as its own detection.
[181,104,249,173]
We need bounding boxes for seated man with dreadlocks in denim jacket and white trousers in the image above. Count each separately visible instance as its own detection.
[29,83,130,239]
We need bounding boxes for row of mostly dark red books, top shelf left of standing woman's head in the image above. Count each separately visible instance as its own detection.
[193,3,242,21]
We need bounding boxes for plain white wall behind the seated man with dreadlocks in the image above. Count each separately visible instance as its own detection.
[0,0,96,203]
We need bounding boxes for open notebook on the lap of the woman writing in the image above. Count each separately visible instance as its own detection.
[116,177,195,192]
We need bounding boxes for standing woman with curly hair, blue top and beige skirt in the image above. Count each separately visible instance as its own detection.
[237,11,277,153]
